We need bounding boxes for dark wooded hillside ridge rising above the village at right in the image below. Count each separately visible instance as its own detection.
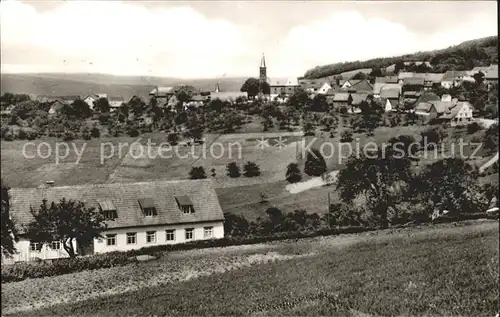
[304,36,498,79]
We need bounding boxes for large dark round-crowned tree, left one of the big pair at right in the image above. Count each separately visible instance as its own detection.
[337,151,411,228]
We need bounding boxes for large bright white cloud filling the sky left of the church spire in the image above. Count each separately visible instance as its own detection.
[0,1,254,77]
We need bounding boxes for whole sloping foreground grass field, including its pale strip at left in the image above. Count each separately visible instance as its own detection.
[2,221,500,316]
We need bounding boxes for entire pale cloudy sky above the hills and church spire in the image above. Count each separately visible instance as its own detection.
[0,0,497,78]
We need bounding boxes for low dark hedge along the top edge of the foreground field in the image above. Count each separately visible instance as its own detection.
[2,213,498,283]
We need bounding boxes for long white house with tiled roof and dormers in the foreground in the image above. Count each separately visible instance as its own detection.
[5,180,224,262]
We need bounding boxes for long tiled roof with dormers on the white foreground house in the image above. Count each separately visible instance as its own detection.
[9,179,224,228]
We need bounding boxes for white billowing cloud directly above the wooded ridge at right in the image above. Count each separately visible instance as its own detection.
[278,11,497,75]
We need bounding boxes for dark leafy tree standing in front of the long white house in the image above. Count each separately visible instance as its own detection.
[26,198,106,258]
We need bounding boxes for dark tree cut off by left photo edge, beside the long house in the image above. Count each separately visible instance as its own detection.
[0,179,17,257]
